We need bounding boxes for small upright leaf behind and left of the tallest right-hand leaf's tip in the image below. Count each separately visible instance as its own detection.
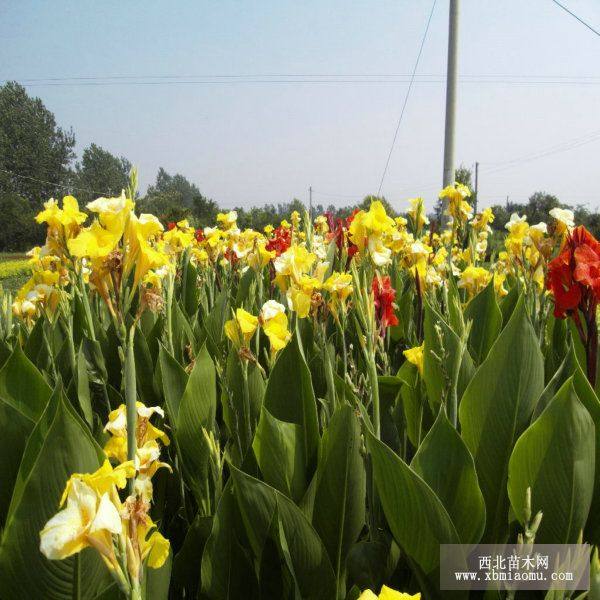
[465,278,502,364]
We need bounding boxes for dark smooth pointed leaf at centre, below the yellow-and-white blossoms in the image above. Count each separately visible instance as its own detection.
[264,334,319,472]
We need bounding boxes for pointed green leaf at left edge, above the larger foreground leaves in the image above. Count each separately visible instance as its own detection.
[0,344,52,421]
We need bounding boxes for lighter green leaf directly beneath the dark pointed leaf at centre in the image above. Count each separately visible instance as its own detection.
[252,406,307,503]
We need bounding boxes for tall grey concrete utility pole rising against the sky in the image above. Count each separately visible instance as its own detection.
[443,0,459,187]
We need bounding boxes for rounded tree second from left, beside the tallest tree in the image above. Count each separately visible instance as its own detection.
[73,144,131,202]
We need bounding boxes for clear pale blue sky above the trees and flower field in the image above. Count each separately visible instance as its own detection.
[0,0,600,208]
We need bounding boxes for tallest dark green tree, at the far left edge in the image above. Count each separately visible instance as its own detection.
[0,82,75,208]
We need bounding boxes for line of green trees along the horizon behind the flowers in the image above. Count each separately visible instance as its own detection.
[0,82,600,252]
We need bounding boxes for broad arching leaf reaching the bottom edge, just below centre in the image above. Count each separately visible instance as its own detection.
[232,467,335,600]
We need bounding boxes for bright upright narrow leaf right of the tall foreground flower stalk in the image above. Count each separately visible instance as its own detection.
[175,346,217,502]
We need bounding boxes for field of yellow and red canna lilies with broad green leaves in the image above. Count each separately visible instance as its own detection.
[0,173,600,600]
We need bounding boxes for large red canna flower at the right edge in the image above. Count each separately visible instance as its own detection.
[546,225,600,386]
